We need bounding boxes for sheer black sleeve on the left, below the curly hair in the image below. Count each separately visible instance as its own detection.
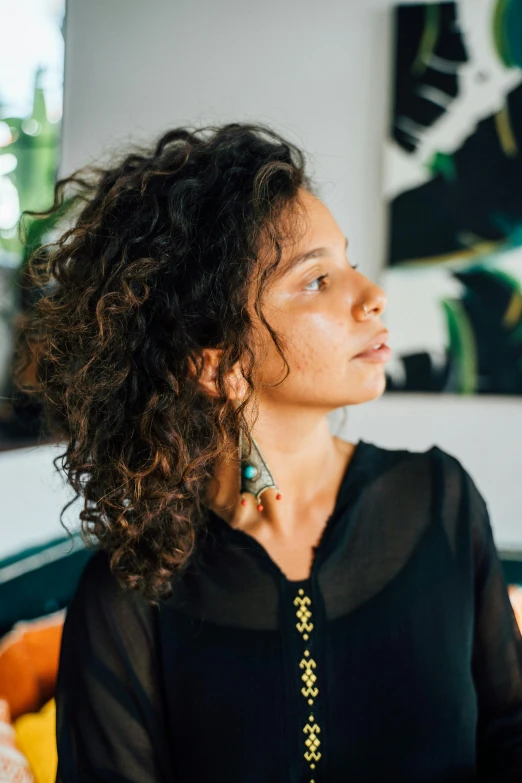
[56,551,174,783]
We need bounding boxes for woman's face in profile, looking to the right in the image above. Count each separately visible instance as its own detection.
[247,190,387,412]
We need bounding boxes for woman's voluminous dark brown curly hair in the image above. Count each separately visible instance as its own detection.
[14,123,316,602]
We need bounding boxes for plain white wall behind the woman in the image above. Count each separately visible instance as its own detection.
[0,0,522,554]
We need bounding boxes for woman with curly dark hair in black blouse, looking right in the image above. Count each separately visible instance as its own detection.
[16,123,522,783]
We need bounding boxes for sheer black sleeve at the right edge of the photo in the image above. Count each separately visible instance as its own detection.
[464,471,522,783]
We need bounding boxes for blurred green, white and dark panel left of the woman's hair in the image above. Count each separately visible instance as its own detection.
[0,0,66,451]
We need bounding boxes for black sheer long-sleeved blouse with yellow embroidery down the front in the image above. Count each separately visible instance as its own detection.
[56,440,522,783]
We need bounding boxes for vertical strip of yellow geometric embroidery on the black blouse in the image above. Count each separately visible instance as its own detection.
[294,588,321,783]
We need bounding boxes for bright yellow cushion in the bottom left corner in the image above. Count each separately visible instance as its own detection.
[13,699,58,783]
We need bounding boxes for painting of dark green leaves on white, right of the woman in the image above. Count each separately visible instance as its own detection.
[380,0,522,394]
